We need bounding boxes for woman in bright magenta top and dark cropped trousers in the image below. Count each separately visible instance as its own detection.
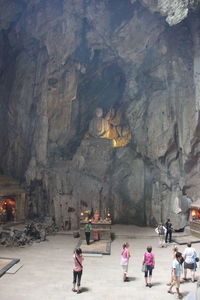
[143,246,155,288]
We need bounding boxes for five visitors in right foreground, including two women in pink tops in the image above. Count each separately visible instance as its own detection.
[121,242,199,299]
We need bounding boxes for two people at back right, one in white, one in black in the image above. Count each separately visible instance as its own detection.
[155,219,173,247]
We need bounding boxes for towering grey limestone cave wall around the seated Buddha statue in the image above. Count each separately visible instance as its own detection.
[0,0,200,229]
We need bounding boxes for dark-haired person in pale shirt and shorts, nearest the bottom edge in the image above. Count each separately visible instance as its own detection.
[167,252,183,299]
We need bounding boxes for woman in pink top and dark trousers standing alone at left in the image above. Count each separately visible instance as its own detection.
[72,248,84,294]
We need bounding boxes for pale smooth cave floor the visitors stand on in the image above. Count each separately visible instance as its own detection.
[0,225,200,300]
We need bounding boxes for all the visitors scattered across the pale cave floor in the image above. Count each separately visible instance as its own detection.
[72,219,199,298]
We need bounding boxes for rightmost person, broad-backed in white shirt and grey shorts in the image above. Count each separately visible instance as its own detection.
[183,242,197,282]
